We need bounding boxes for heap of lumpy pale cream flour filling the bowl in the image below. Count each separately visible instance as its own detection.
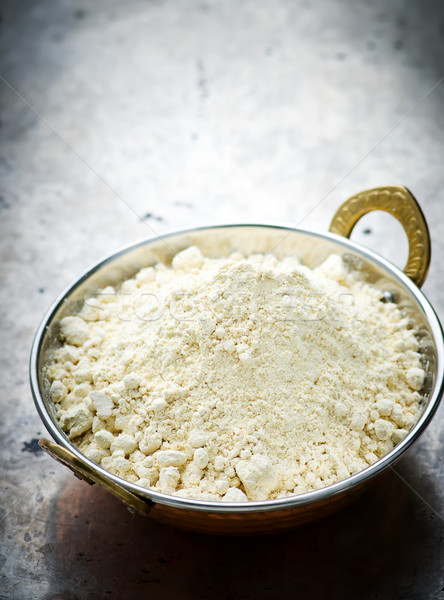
[47,247,424,502]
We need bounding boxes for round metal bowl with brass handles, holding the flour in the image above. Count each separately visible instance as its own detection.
[30,187,444,534]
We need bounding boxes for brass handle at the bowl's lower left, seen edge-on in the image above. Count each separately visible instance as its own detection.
[39,438,151,516]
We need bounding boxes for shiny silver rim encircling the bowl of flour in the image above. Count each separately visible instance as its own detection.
[29,223,444,514]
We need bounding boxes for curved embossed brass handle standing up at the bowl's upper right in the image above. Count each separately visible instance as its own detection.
[330,185,431,287]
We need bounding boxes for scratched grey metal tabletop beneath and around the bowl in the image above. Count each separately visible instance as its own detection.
[0,0,444,600]
